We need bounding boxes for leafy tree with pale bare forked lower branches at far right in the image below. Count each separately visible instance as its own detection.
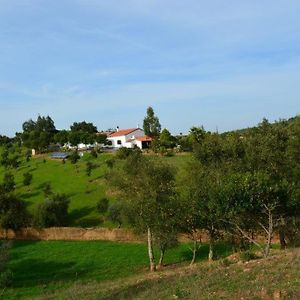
[220,172,289,257]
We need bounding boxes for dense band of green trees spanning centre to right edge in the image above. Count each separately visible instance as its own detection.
[107,117,300,270]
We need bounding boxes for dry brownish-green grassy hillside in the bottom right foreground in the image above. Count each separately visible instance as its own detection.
[40,249,300,300]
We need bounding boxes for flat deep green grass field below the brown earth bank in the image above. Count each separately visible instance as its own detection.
[3,241,231,299]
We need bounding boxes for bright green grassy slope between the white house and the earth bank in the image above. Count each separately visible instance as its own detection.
[0,149,190,227]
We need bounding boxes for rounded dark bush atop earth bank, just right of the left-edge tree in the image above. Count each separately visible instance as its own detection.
[34,194,69,227]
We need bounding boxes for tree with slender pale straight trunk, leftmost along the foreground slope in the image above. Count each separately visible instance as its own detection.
[108,152,177,271]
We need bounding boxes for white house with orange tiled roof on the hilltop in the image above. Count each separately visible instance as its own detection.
[107,128,152,149]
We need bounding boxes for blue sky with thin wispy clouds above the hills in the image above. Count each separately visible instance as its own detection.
[0,0,300,136]
